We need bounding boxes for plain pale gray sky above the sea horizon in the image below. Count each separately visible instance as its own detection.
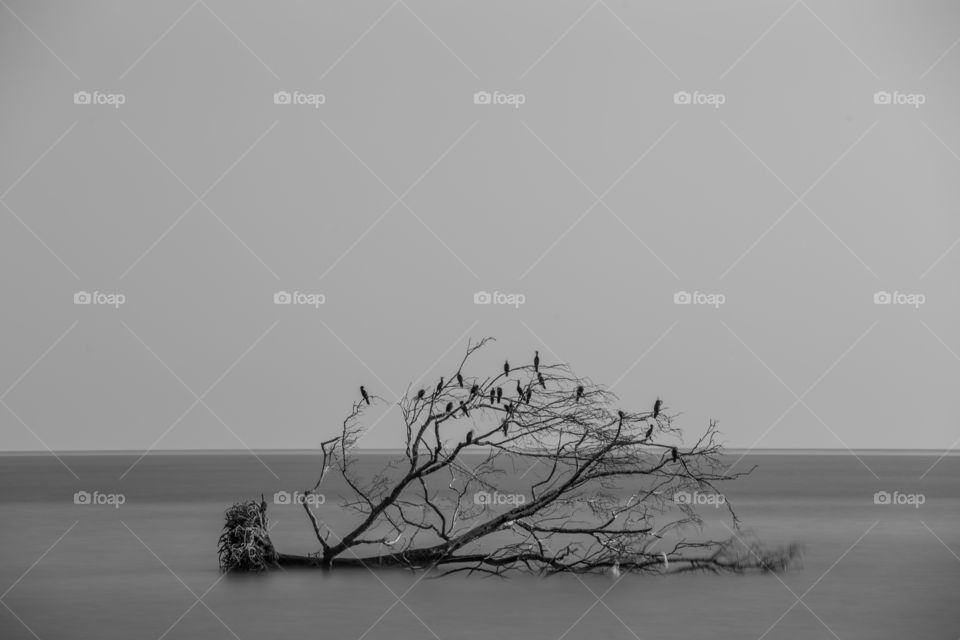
[0,0,960,450]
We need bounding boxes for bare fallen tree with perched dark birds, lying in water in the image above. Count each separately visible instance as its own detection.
[219,338,800,575]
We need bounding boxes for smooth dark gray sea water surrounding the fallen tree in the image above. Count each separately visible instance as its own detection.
[0,454,960,640]
